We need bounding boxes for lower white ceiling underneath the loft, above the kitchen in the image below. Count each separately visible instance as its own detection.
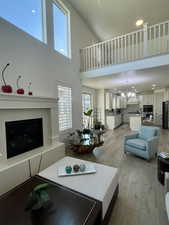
[83,66,169,92]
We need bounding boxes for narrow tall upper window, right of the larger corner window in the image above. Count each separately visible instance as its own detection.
[53,1,70,56]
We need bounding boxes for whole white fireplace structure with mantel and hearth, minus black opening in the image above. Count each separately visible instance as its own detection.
[0,93,65,195]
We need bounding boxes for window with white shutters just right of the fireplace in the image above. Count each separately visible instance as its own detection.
[58,85,72,131]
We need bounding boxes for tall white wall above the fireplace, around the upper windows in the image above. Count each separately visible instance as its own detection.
[0,0,96,135]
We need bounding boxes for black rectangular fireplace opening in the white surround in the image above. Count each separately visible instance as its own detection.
[5,118,43,159]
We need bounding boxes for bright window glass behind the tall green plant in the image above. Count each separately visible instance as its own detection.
[82,93,92,127]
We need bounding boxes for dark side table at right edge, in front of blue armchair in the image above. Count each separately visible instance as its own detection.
[158,156,169,185]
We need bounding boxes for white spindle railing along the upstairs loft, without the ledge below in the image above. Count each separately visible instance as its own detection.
[80,21,169,72]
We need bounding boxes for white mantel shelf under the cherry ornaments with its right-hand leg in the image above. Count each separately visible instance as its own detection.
[0,93,59,162]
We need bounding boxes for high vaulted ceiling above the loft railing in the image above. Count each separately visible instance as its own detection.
[69,0,169,40]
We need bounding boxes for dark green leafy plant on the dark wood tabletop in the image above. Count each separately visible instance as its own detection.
[25,183,50,212]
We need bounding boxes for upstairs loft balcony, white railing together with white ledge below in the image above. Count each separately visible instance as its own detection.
[80,21,169,77]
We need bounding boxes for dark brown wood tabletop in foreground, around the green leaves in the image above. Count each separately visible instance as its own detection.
[0,176,102,225]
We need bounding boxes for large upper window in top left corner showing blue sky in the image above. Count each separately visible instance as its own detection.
[0,0,43,41]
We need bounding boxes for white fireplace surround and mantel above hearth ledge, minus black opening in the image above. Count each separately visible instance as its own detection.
[0,94,59,162]
